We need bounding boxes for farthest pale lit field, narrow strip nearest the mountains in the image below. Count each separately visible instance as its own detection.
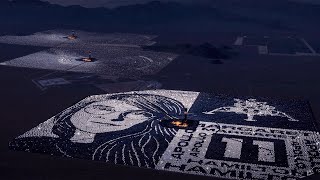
[0,30,157,47]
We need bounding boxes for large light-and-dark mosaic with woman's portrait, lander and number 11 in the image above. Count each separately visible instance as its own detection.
[9,90,320,179]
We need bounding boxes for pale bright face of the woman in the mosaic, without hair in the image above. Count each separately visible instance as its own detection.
[70,99,153,134]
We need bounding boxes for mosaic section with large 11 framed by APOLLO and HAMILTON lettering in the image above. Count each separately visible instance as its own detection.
[156,122,320,180]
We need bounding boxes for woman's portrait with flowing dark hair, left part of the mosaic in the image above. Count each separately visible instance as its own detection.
[11,93,184,168]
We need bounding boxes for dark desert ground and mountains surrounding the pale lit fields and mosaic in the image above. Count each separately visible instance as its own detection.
[0,0,320,180]
